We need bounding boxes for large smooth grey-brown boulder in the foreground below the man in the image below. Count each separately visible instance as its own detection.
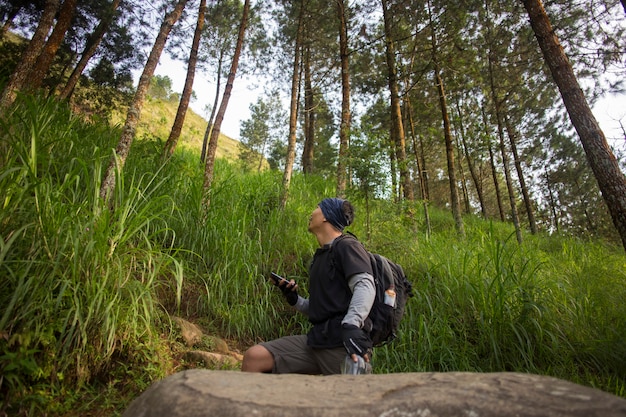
[122,369,626,417]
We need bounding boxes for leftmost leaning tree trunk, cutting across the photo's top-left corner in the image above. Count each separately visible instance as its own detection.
[0,0,60,113]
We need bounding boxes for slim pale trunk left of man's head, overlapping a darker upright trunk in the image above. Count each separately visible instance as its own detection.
[280,0,304,209]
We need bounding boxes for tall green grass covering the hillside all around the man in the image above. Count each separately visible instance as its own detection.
[0,93,626,416]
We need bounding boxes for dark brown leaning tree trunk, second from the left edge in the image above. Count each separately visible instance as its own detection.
[28,0,77,90]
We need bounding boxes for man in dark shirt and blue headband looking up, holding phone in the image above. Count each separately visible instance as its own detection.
[241,198,375,375]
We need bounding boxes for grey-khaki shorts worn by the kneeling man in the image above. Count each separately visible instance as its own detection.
[260,335,347,375]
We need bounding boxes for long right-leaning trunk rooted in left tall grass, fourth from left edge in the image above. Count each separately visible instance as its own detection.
[100,0,187,203]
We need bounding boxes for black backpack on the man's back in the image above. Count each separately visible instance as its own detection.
[334,232,413,347]
